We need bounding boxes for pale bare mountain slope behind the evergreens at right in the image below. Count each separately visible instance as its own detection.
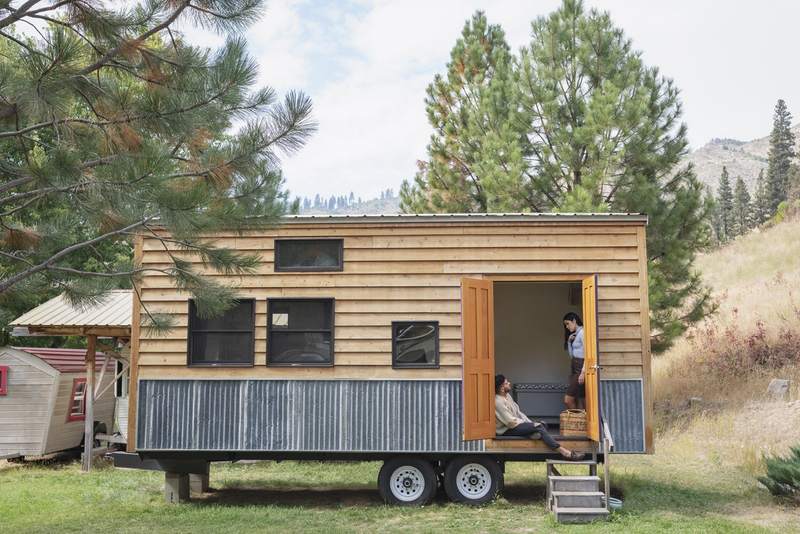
[683,124,800,194]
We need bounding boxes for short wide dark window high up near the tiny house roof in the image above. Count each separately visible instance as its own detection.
[275,239,344,272]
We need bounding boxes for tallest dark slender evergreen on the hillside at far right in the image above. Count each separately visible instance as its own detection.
[767,100,795,211]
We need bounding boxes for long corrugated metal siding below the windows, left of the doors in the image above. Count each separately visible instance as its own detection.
[137,380,483,452]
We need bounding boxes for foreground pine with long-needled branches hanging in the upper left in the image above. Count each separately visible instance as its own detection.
[0,0,314,327]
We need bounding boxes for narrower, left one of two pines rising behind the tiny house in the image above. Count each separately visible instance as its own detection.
[400,11,530,213]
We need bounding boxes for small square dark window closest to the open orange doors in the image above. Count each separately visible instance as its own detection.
[392,321,439,368]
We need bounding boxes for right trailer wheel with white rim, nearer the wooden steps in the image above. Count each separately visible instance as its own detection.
[444,456,503,506]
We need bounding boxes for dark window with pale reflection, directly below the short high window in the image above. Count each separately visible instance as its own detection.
[267,299,333,366]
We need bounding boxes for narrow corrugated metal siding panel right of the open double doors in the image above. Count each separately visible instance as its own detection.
[600,380,645,452]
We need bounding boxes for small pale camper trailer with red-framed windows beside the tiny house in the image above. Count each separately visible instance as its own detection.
[0,347,114,458]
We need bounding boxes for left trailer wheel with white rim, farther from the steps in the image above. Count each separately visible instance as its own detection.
[378,456,436,506]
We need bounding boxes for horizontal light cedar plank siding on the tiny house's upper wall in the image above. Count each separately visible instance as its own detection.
[139,222,643,379]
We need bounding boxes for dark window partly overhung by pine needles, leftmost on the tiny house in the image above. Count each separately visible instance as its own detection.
[188,299,255,366]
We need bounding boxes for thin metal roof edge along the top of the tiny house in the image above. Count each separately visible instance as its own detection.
[281,213,647,224]
